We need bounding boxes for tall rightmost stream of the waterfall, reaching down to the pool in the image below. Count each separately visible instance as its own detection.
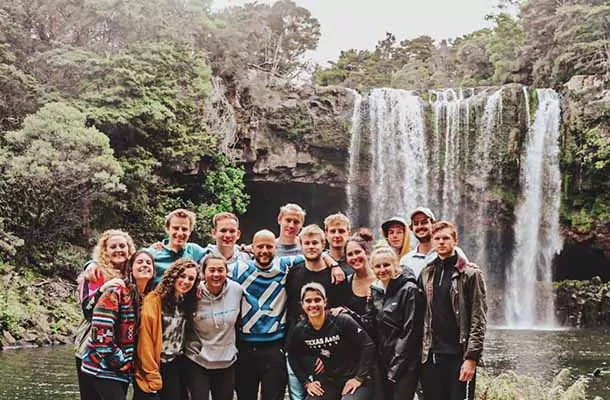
[506,89,563,327]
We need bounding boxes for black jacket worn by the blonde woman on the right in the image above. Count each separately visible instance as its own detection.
[364,268,425,382]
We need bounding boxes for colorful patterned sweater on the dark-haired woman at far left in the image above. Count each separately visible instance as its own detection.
[81,286,136,382]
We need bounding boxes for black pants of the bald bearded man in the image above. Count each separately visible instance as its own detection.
[236,341,288,400]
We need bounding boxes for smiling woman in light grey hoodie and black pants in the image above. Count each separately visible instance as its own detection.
[185,254,244,400]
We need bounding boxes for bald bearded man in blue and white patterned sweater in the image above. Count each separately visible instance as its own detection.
[230,229,345,400]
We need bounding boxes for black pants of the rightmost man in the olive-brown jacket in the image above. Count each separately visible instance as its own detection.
[421,354,476,400]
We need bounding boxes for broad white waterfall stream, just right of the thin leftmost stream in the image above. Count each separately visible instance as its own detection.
[367,88,428,228]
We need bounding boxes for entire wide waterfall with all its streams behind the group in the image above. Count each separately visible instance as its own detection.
[347,86,562,326]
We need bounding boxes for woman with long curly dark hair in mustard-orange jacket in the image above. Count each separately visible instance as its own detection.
[134,258,199,400]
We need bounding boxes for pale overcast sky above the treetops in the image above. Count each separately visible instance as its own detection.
[214,0,499,62]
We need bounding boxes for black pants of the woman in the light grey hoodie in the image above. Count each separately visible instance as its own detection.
[184,359,235,400]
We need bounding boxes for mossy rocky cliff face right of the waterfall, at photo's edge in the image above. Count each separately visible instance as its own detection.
[563,75,610,268]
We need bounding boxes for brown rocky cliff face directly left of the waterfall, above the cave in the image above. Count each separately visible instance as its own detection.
[228,79,353,187]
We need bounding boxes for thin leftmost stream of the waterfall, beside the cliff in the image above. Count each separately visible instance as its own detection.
[346,89,362,222]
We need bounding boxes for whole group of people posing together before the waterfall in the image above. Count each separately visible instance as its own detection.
[75,204,487,400]
